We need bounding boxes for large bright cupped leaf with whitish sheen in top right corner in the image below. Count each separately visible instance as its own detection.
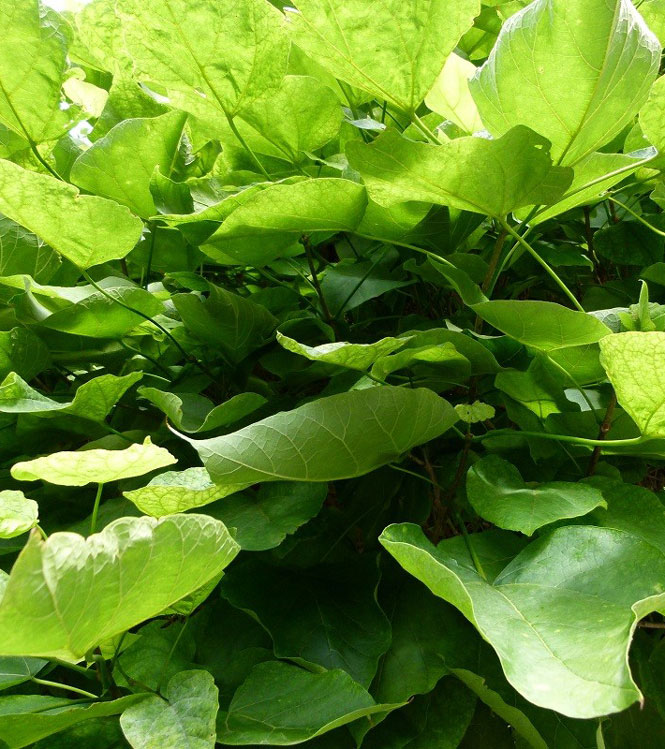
[470,0,660,166]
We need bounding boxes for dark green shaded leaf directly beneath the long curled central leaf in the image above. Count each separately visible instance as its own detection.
[205,480,328,551]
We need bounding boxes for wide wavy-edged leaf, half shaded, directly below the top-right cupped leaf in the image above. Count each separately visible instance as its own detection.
[347,126,573,218]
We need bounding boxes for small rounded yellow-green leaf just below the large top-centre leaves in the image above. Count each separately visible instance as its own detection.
[242,75,342,164]
